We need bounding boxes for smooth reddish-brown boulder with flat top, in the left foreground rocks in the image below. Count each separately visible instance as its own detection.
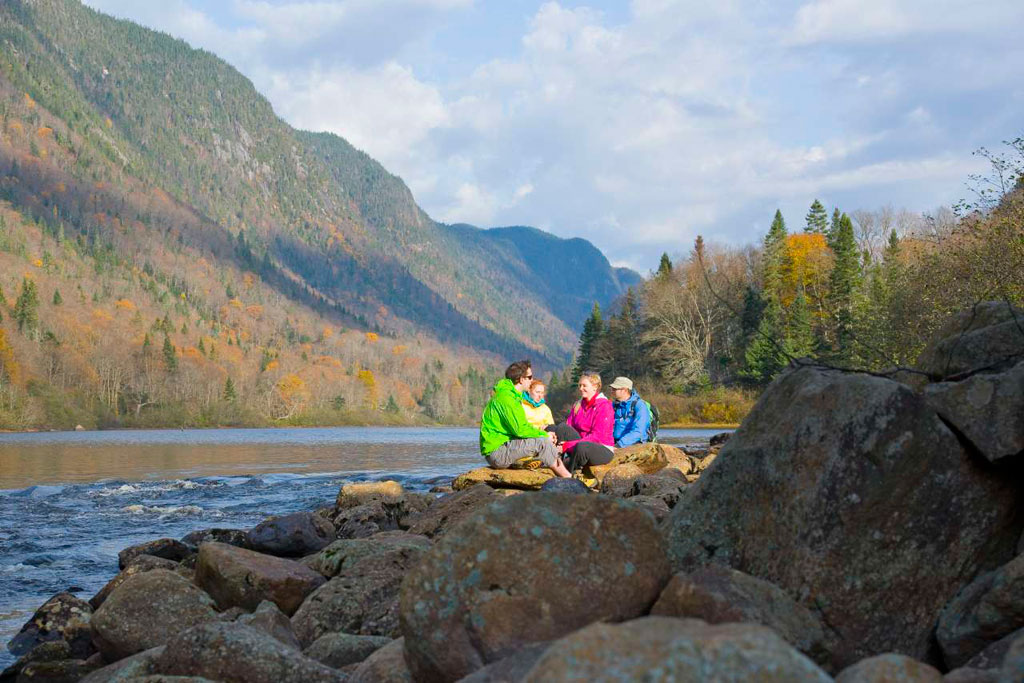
[196,543,324,616]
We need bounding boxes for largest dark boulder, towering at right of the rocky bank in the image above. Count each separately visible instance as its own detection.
[665,367,1020,670]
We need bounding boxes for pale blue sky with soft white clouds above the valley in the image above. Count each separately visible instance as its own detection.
[86,0,1024,272]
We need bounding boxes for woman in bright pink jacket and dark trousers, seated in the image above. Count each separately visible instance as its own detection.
[556,373,615,471]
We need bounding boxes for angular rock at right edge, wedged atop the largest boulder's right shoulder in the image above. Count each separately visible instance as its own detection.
[925,360,1024,463]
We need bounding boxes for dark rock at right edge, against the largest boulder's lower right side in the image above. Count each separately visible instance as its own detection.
[936,555,1024,667]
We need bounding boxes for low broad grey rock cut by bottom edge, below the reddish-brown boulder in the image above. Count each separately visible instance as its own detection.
[158,624,346,683]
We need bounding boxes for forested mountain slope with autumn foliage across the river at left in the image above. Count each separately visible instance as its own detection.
[0,0,638,426]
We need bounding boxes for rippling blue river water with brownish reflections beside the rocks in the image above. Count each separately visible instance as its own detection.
[0,427,720,670]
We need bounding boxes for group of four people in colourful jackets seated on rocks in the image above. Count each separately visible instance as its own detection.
[480,360,650,477]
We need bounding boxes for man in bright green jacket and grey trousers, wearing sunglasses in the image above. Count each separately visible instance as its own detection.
[480,360,571,477]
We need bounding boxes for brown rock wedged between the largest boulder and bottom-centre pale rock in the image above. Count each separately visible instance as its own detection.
[650,565,824,659]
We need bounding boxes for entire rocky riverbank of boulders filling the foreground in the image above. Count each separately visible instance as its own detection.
[0,303,1024,683]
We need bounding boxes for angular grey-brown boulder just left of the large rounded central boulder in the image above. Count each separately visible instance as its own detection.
[292,531,430,646]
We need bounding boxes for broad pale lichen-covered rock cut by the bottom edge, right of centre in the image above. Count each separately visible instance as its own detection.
[522,616,831,683]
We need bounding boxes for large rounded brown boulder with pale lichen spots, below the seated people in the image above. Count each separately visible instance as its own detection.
[401,494,669,680]
